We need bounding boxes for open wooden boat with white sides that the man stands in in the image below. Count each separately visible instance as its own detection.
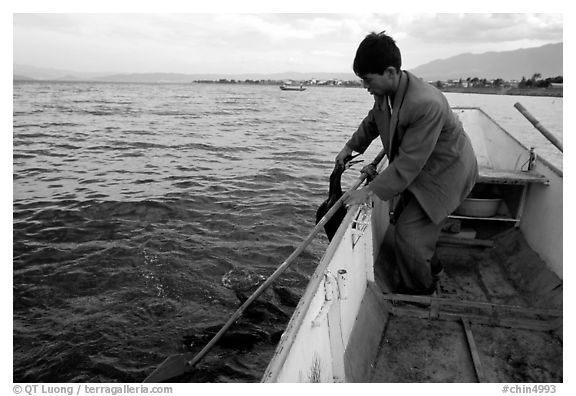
[262,108,563,382]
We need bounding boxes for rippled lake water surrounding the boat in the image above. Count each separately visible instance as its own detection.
[13,82,562,382]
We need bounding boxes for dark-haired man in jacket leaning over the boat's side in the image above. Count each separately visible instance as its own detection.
[336,32,478,294]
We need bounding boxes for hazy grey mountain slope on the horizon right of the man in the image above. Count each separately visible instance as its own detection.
[411,43,563,81]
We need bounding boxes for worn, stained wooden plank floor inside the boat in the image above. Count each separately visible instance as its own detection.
[369,229,563,382]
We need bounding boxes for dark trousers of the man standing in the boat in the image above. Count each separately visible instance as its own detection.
[393,191,442,294]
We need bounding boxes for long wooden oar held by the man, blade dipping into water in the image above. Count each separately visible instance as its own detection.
[144,150,385,382]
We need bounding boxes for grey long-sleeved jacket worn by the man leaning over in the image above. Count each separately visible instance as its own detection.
[346,71,478,224]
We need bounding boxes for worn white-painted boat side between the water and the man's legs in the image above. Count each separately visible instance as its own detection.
[262,207,374,382]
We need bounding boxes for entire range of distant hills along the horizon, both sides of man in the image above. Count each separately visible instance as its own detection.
[13,43,563,83]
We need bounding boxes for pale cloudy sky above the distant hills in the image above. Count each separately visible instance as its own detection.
[13,10,564,74]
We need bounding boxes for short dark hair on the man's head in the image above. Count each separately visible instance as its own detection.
[353,31,402,77]
